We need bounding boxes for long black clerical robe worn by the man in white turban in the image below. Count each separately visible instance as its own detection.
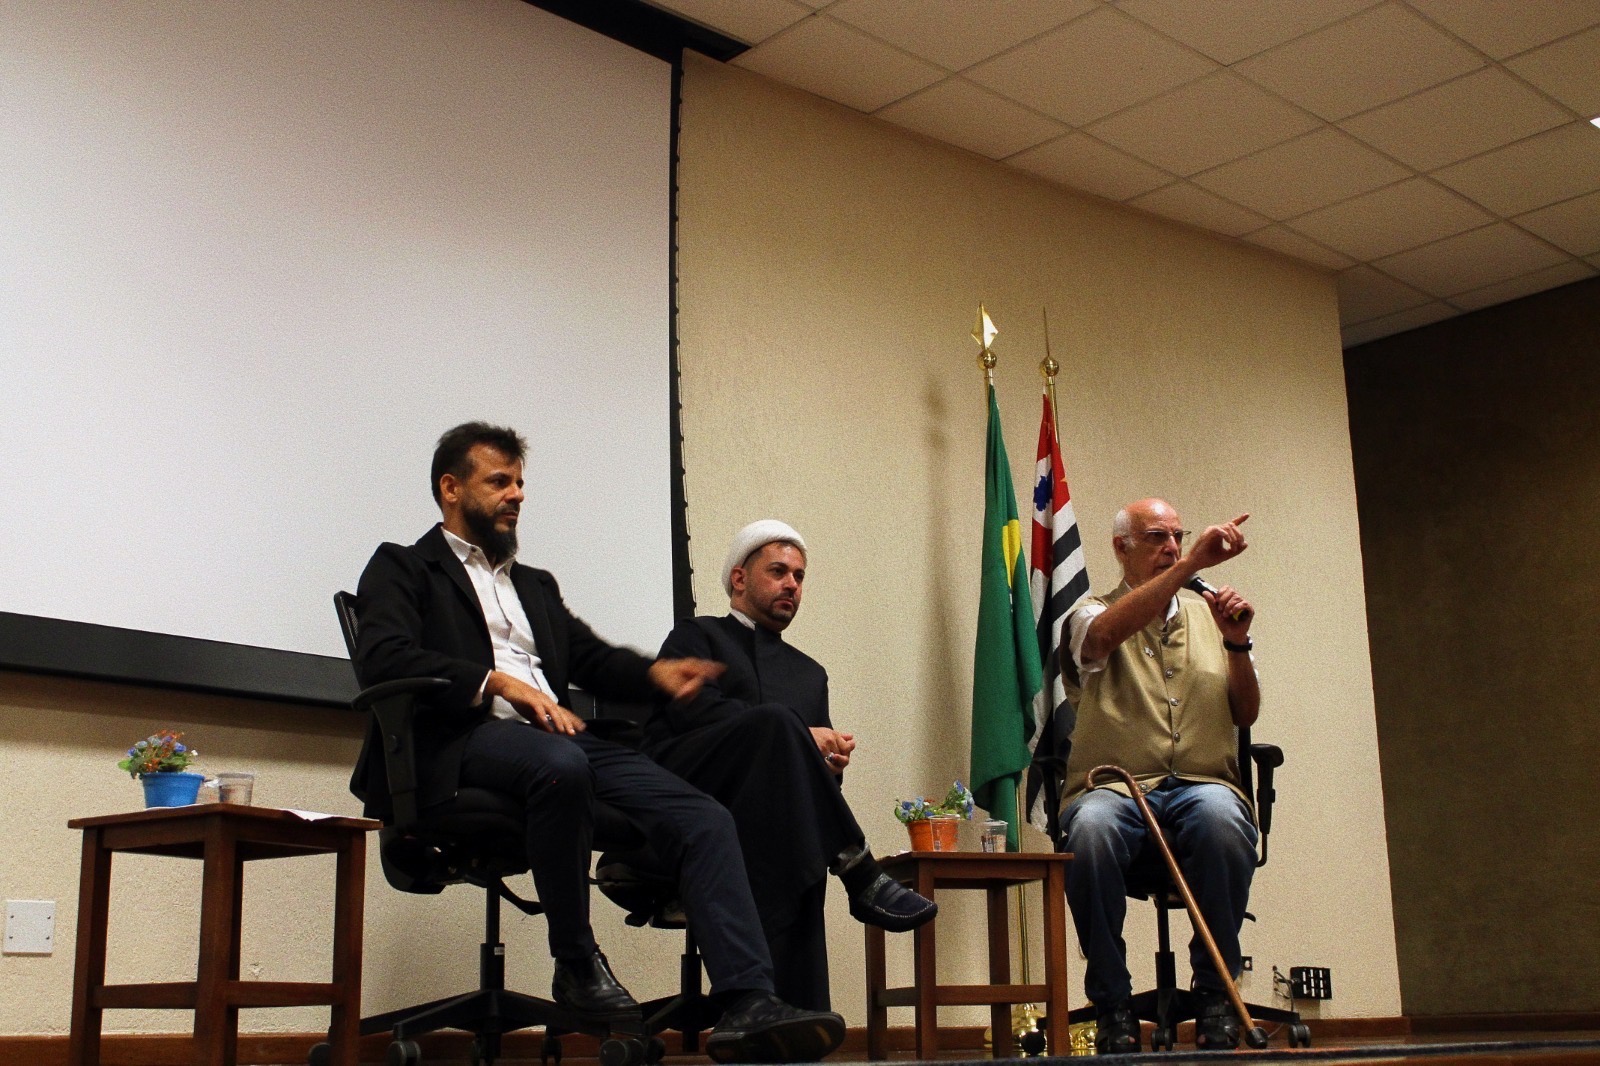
[645,615,862,1010]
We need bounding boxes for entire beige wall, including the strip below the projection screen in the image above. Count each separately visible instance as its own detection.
[0,52,1400,1032]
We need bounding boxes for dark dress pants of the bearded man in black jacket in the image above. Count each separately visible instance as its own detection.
[461,719,773,992]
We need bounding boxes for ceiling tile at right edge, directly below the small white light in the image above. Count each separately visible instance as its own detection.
[1434,122,1600,216]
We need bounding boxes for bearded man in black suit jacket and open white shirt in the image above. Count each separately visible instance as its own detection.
[350,423,845,1061]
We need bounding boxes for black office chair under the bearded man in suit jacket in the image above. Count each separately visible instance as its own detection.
[310,592,672,1066]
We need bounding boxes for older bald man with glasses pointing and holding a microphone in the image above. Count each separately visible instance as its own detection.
[1061,499,1261,1055]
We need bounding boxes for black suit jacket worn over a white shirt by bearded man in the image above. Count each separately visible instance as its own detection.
[350,525,653,818]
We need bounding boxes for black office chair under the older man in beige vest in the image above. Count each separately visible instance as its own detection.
[1035,730,1310,1055]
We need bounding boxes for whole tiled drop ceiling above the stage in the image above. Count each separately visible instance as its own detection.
[650,0,1600,346]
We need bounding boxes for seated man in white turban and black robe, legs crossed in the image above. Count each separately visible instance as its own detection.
[645,519,938,1010]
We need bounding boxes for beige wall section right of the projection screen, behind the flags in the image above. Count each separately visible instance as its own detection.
[678,59,1400,1021]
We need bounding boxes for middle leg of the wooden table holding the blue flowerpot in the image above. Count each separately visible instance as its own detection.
[195,818,245,1066]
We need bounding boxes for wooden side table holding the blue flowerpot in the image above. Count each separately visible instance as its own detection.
[67,804,379,1066]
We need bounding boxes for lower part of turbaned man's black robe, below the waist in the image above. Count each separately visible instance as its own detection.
[650,703,862,1010]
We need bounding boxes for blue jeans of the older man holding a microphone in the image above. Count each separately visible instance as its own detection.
[1061,778,1256,1007]
